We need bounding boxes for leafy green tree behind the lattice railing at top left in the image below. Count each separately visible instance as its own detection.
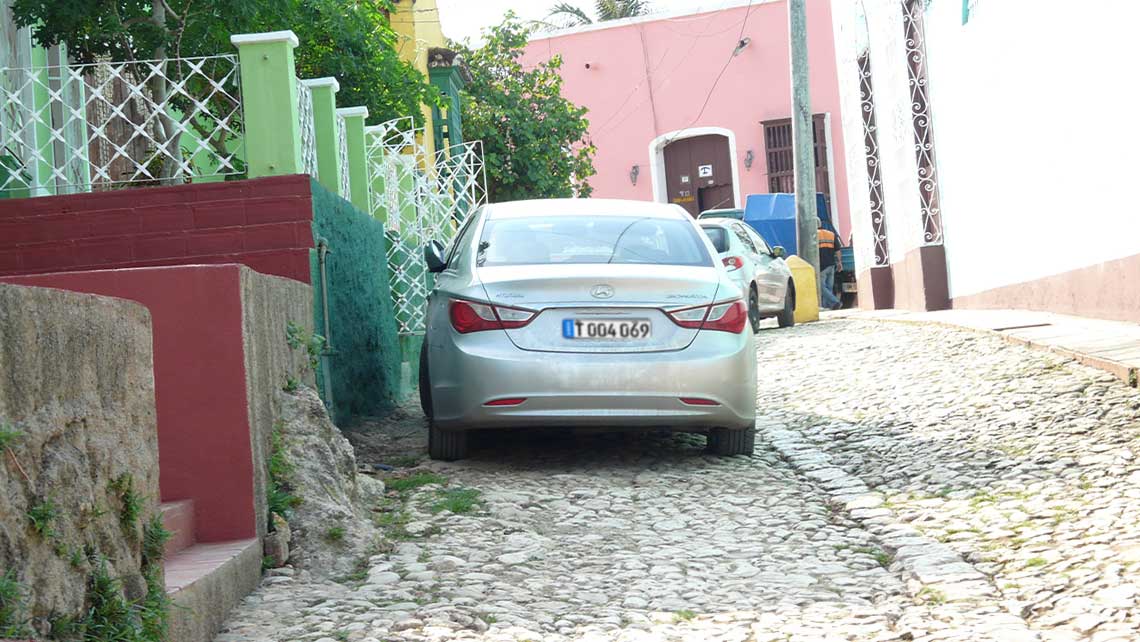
[11,0,438,178]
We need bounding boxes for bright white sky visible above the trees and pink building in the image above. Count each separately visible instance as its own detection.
[437,0,726,42]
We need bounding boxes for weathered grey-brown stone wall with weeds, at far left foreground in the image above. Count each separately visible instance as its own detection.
[0,284,158,632]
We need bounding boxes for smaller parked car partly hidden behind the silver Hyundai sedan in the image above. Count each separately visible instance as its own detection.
[700,218,796,332]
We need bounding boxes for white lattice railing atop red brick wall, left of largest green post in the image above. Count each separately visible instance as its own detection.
[0,56,245,196]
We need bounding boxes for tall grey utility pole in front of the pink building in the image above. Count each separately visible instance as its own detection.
[788,0,822,296]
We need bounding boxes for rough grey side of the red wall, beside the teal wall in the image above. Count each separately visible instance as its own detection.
[241,268,314,535]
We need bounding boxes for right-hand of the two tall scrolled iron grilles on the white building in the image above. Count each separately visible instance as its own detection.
[902,0,942,245]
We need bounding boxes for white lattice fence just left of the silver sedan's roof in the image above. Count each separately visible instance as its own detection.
[367,117,487,335]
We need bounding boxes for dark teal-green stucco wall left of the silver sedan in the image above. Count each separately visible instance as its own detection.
[311,180,418,423]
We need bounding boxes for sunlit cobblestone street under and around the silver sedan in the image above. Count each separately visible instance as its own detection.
[218,320,1140,642]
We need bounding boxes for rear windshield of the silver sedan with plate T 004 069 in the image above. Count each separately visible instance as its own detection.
[478,216,713,267]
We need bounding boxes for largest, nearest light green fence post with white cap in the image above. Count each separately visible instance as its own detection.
[229,31,304,178]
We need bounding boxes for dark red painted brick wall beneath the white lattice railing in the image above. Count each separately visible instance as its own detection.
[0,174,314,283]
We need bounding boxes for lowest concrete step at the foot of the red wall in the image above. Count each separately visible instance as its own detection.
[164,538,262,642]
